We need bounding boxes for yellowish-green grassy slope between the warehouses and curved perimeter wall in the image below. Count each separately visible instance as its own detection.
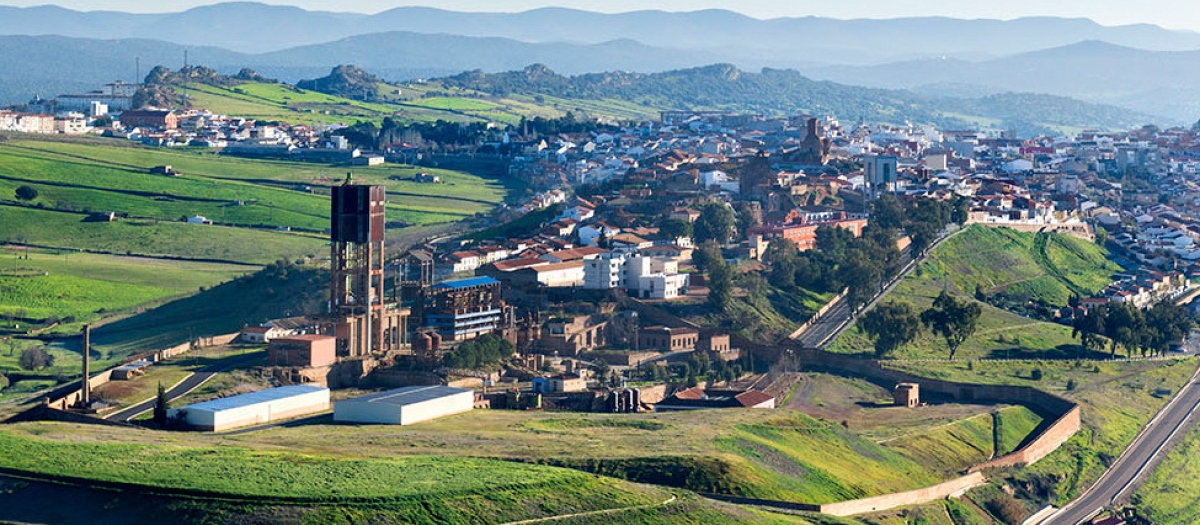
[11,410,1041,502]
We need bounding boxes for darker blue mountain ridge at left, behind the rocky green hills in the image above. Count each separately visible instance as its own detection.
[0,32,718,104]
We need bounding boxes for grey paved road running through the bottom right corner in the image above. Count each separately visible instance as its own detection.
[1042,366,1200,525]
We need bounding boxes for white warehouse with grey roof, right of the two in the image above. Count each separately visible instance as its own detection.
[334,385,475,424]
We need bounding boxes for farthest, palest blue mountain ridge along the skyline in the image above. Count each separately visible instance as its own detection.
[0,2,1200,66]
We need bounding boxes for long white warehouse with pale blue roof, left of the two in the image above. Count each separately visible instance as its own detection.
[167,385,329,432]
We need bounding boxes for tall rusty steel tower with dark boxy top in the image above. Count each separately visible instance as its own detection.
[330,174,390,356]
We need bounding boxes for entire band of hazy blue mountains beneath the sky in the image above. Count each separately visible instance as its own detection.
[0,2,1200,123]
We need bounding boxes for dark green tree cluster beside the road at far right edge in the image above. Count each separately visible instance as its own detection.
[1073,301,1194,357]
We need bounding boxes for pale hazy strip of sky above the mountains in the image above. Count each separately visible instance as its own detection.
[9,0,1200,30]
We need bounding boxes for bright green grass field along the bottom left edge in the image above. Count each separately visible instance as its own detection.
[0,432,668,523]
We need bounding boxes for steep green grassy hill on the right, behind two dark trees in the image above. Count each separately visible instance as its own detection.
[829,225,1120,358]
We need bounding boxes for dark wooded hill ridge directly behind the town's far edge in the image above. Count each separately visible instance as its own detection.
[439,64,1150,134]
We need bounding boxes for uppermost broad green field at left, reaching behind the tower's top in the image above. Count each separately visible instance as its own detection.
[0,141,504,233]
